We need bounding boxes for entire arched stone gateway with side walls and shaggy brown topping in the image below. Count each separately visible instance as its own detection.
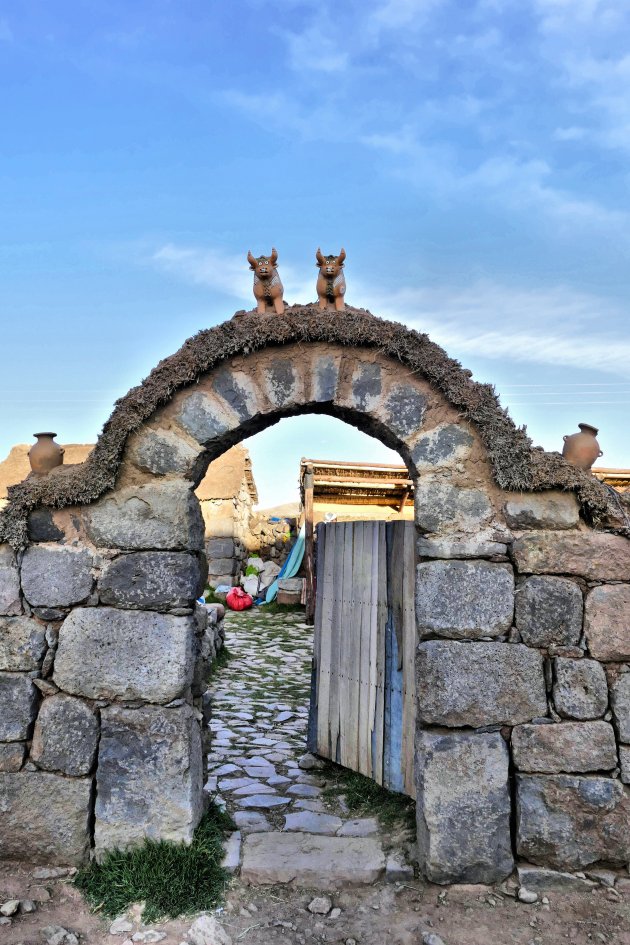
[0,306,630,882]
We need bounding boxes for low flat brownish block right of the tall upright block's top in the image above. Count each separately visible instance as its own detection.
[512,722,617,774]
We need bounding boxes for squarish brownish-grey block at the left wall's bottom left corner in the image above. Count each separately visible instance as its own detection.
[0,771,92,866]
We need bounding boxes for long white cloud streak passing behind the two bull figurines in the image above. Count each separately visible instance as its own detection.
[150,243,630,378]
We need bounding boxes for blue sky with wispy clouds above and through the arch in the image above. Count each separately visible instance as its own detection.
[0,0,630,501]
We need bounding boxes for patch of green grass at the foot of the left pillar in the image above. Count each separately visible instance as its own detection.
[74,805,235,923]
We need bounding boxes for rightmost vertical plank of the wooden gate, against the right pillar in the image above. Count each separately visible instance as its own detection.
[402,522,417,797]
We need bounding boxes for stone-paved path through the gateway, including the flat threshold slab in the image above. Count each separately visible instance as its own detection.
[206,611,409,886]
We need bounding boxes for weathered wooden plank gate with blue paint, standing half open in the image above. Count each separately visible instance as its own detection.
[309,521,416,797]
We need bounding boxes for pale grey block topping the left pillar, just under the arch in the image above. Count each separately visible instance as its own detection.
[86,479,205,551]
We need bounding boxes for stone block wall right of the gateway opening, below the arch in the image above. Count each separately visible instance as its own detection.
[416,484,630,888]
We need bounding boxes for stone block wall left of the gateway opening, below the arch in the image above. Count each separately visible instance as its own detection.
[0,524,223,864]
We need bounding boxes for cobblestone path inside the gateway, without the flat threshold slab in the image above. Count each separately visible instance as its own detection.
[207,611,320,833]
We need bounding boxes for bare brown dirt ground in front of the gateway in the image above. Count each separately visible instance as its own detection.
[0,864,630,945]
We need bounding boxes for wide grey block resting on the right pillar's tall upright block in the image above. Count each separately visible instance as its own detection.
[416,640,547,728]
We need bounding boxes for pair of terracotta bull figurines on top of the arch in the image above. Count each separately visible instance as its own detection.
[247,249,346,315]
